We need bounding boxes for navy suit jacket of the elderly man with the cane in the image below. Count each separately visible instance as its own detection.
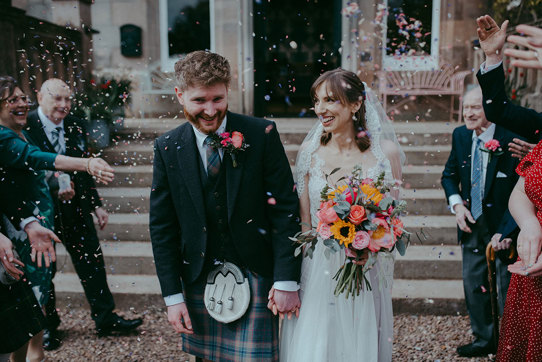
[441,126,519,241]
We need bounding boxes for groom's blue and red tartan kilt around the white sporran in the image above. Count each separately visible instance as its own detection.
[182,269,279,361]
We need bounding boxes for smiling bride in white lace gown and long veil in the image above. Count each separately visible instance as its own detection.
[280,69,404,362]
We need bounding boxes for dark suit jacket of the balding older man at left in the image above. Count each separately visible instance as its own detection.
[27,110,102,219]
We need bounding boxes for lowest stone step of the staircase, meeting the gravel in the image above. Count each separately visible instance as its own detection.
[54,272,466,315]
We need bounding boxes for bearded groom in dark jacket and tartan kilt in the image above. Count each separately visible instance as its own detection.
[150,51,301,361]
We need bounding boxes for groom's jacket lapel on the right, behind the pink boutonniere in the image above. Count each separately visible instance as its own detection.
[222,112,249,221]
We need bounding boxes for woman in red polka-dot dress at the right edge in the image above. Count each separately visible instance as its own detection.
[497,142,542,361]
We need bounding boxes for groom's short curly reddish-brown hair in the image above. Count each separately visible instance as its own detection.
[175,50,231,90]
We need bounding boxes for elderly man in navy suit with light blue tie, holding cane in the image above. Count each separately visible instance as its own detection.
[441,88,518,357]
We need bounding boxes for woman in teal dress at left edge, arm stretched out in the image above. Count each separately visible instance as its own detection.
[0,76,113,360]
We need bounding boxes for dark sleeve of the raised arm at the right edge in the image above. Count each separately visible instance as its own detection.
[476,64,542,143]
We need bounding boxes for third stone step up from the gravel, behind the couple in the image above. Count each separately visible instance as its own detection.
[98,213,457,245]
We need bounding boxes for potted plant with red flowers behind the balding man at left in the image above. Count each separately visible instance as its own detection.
[74,76,132,149]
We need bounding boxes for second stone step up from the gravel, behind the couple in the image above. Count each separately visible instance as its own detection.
[57,241,461,280]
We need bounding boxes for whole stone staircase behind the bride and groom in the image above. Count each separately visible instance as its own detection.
[55,119,465,314]
